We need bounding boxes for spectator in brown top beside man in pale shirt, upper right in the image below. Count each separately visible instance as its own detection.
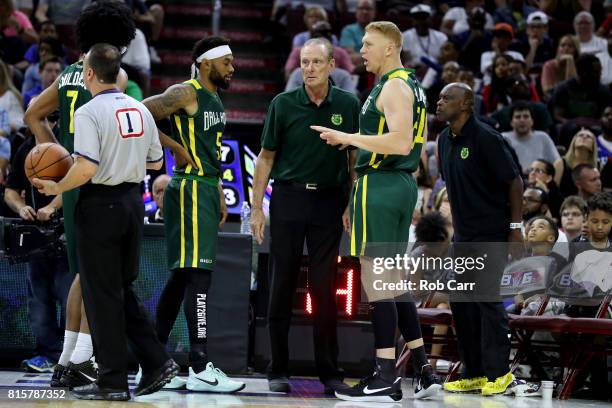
[542,35,580,99]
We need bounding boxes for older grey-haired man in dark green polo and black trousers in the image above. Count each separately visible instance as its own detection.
[251,38,359,395]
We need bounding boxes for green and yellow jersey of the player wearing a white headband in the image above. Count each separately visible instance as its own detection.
[170,79,226,178]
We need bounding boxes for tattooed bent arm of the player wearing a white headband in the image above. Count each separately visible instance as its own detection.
[142,84,198,169]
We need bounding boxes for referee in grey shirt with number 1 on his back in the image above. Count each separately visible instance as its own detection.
[33,44,179,401]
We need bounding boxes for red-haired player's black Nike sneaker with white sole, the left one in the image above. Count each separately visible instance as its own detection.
[336,371,402,402]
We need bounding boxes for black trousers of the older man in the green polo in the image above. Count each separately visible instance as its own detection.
[268,183,346,382]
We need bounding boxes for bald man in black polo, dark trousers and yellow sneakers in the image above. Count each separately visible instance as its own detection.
[436,83,523,395]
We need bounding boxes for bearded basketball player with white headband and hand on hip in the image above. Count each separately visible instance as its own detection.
[143,37,245,392]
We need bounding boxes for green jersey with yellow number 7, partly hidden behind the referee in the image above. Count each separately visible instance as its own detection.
[57,61,91,153]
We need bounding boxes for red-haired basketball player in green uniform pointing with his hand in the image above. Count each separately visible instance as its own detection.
[312,21,441,402]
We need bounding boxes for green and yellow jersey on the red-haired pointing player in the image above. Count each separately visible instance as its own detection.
[355,68,427,176]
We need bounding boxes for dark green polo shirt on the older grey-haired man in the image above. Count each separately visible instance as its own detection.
[261,83,359,186]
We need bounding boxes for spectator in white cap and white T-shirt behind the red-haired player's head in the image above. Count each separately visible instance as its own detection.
[403,4,448,68]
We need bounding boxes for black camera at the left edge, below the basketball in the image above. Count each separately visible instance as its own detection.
[0,216,66,265]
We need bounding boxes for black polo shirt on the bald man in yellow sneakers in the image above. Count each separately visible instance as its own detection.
[438,115,520,242]
